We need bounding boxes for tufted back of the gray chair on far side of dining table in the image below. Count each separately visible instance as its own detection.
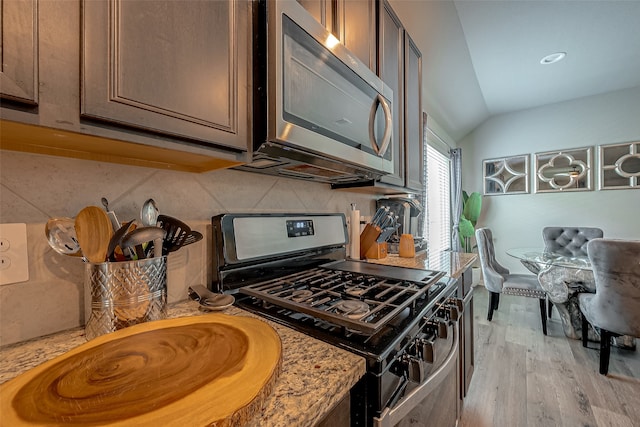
[542,227,604,256]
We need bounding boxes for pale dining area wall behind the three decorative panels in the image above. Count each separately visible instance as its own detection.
[459,87,640,272]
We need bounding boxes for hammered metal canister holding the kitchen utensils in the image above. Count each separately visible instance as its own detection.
[85,256,167,340]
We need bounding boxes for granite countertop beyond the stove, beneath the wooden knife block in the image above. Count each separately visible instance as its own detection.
[367,251,478,279]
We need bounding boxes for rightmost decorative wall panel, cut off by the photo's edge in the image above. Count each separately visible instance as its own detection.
[598,141,640,190]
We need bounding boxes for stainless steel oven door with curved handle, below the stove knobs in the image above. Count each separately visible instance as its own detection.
[373,320,460,427]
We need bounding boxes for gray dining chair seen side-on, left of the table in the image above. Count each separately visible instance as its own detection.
[476,227,547,335]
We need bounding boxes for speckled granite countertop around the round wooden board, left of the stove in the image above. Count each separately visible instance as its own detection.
[0,300,366,427]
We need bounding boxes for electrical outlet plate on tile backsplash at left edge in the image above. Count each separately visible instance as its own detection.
[0,224,29,285]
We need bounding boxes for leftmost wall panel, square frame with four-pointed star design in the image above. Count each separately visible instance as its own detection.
[482,154,529,195]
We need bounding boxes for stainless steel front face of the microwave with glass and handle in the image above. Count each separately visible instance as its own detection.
[264,1,398,173]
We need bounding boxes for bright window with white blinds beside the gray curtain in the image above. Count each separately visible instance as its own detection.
[423,125,451,254]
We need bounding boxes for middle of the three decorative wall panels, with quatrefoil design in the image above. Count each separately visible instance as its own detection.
[534,147,593,193]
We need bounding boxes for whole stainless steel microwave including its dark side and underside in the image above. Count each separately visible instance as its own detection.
[239,0,398,183]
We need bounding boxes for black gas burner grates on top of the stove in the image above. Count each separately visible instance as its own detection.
[240,267,442,334]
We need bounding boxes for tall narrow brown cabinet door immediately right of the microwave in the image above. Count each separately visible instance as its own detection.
[378,1,404,186]
